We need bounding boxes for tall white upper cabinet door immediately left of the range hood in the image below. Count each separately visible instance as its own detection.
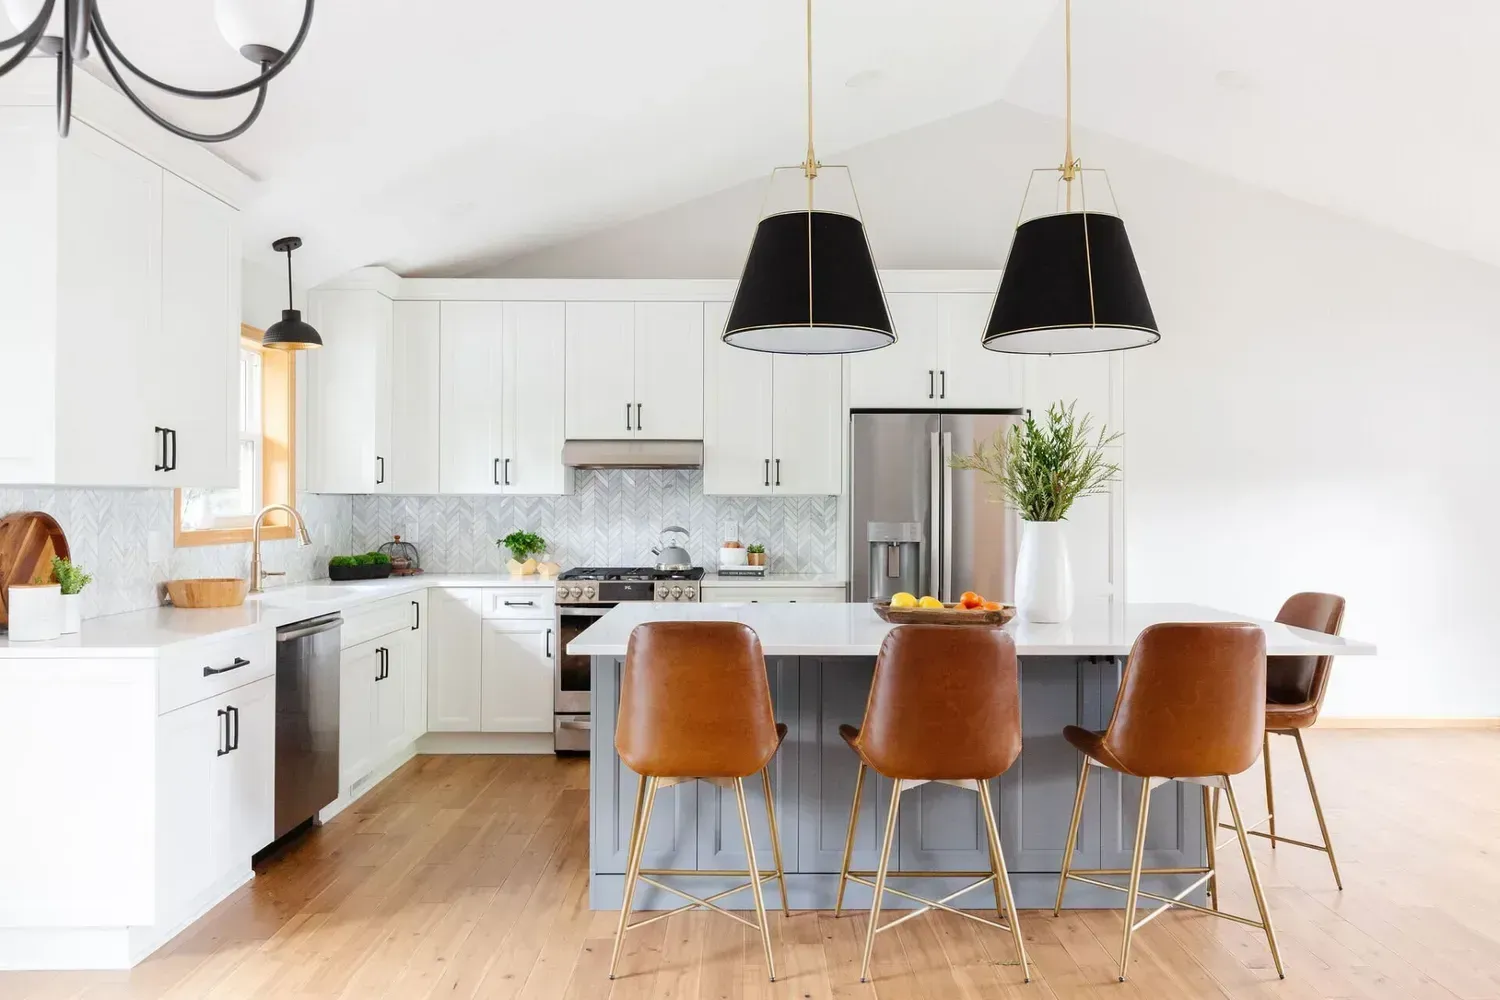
[500,301,573,495]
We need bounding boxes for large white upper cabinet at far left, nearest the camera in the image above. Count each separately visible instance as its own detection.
[0,108,240,487]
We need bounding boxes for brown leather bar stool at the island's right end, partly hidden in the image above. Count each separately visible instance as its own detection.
[1214,591,1344,891]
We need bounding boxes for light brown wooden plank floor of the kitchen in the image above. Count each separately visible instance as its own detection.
[0,730,1500,1000]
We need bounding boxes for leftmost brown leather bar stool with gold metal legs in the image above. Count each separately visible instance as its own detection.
[609,622,788,982]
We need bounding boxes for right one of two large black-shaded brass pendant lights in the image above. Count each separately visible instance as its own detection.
[983,0,1161,354]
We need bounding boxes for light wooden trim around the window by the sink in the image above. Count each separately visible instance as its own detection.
[173,324,297,549]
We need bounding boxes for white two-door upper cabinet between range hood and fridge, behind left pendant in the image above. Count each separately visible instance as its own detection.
[704,303,843,496]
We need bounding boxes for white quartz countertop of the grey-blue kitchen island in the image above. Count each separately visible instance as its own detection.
[567,600,1376,657]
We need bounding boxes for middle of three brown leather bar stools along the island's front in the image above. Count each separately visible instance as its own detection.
[834,625,1031,982]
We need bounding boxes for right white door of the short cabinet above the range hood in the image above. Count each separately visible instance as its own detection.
[635,301,704,441]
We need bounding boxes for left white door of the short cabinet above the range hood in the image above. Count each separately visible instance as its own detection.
[564,301,636,439]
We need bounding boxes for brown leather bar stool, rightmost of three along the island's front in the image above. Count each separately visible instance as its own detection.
[1053,622,1286,982]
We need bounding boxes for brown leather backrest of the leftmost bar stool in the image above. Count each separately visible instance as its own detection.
[615,622,779,778]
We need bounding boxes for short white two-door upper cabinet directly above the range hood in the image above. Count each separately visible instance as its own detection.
[566,301,704,441]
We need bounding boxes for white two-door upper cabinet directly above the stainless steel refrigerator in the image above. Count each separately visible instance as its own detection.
[849,292,1023,409]
